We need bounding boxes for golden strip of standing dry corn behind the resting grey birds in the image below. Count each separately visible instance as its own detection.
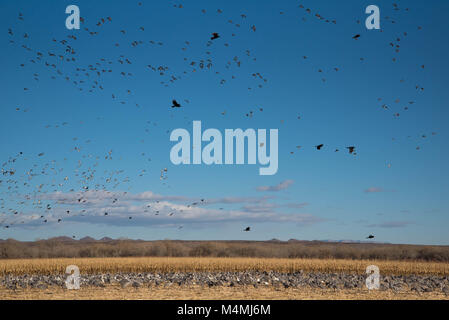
[0,257,449,276]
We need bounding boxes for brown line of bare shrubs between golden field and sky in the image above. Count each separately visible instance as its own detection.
[0,238,449,262]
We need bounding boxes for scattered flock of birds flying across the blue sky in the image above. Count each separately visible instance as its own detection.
[0,2,436,239]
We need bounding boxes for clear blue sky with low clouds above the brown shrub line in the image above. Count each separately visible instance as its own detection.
[0,0,449,244]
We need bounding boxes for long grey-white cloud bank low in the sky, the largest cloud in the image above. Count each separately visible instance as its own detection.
[7,191,324,226]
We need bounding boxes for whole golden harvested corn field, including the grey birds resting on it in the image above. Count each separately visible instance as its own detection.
[0,257,449,299]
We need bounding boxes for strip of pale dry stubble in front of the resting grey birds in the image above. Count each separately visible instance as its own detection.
[0,285,449,300]
